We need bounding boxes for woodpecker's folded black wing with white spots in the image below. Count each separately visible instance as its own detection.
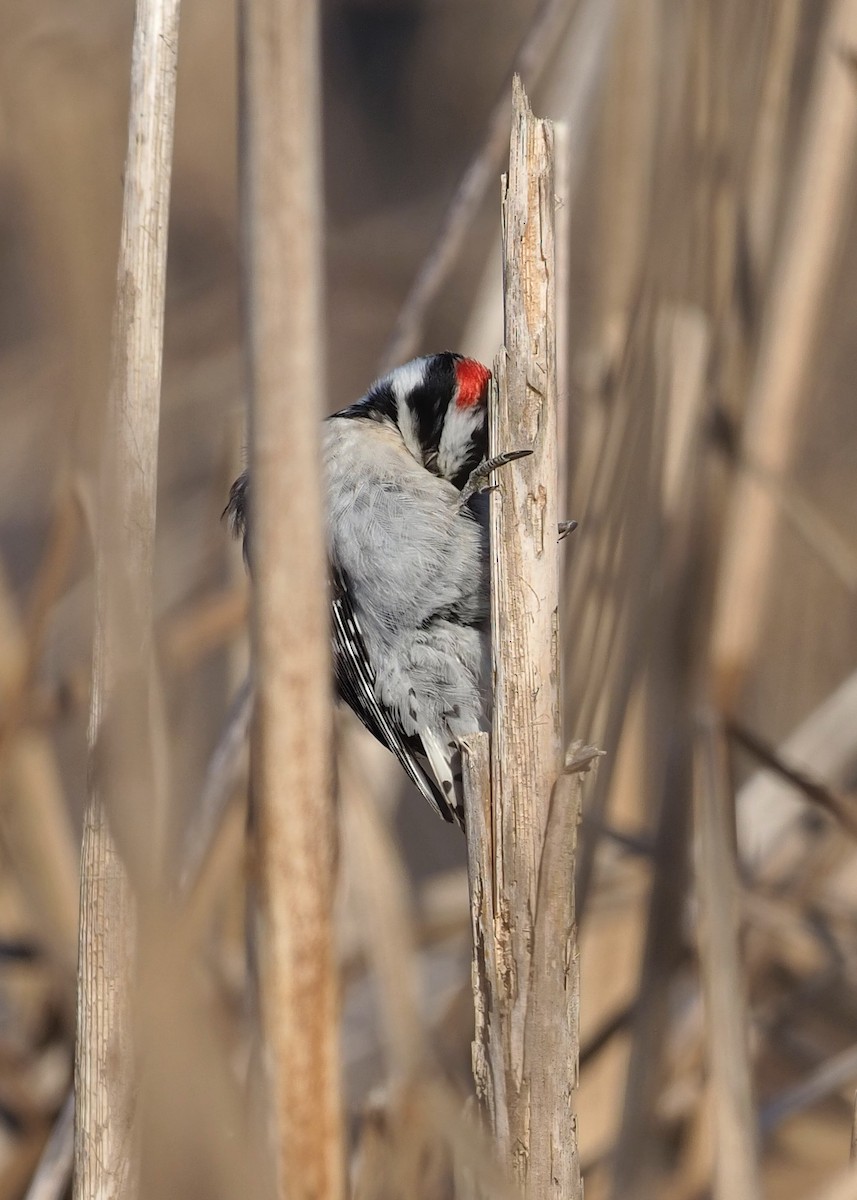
[330,568,454,822]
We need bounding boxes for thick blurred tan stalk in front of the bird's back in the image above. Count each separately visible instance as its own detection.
[241,0,343,1200]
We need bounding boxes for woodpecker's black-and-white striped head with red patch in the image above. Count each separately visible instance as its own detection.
[335,353,491,488]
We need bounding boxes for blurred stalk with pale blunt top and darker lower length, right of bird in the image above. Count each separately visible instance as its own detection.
[609,304,711,1198]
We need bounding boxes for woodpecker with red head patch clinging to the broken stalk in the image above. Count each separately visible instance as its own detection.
[224,352,523,828]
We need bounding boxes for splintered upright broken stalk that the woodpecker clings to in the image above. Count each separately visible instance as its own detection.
[490,79,576,1198]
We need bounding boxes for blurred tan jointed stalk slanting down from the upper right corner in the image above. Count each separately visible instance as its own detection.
[712,0,857,710]
